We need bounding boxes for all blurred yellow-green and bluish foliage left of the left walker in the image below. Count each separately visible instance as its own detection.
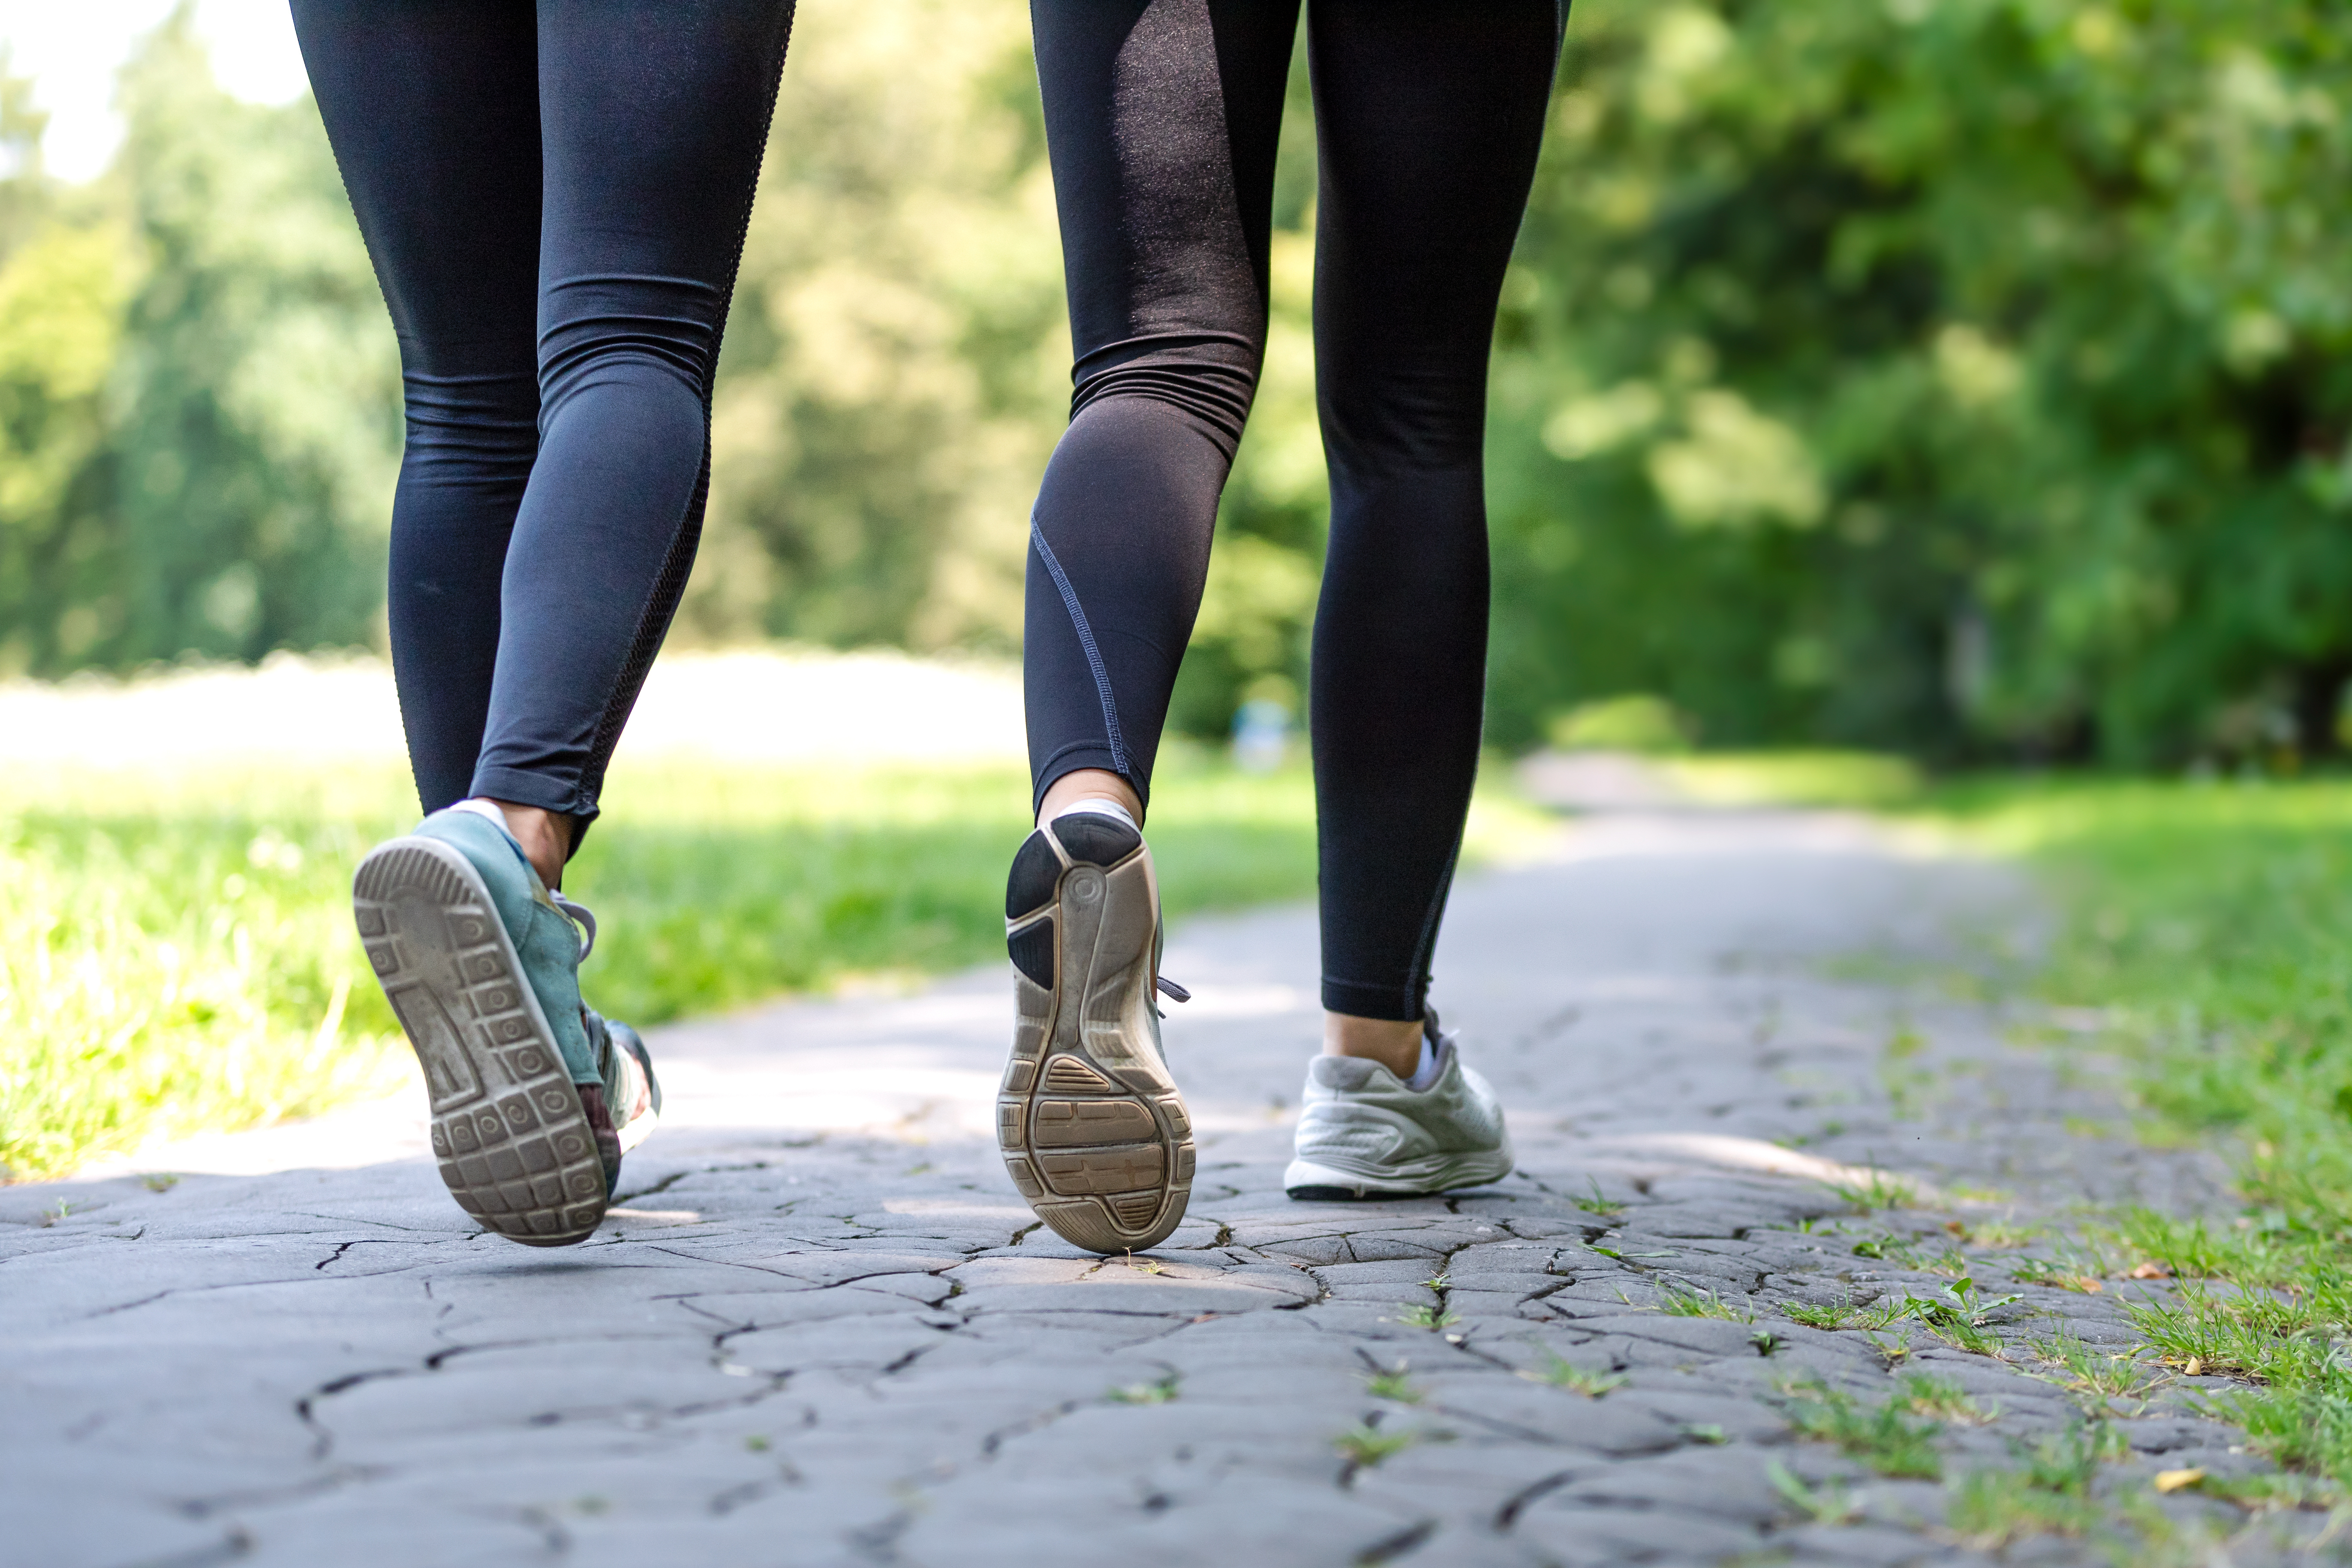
[0,7,400,672]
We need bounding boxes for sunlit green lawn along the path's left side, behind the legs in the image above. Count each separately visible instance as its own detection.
[0,748,1529,1180]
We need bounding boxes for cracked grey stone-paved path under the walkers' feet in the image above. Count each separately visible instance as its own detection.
[0,816,2322,1568]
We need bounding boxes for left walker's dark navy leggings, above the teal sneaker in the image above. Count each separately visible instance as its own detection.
[294,0,793,837]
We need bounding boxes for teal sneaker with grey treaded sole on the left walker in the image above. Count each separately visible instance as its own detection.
[350,807,661,1246]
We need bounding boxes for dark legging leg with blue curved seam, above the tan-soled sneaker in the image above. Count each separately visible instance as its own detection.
[1023,0,1298,804]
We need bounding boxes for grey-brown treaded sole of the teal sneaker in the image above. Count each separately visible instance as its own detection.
[350,839,609,1246]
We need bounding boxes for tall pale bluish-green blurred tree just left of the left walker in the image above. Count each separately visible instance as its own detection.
[105,5,400,663]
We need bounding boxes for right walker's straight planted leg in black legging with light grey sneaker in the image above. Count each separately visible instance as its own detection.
[1284,0,1562,1197]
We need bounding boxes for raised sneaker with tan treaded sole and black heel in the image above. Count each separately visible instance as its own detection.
[997,811,1192,1253]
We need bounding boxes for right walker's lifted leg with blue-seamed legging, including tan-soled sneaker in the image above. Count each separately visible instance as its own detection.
[997,0,1296,1253]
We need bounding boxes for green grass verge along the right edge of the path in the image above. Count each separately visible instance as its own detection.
[1933,778,2352,1488]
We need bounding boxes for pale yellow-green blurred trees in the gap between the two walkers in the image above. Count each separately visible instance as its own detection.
[680,0,1070,651]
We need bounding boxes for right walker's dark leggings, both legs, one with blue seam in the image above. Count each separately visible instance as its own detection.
[1026,0,1564,1020]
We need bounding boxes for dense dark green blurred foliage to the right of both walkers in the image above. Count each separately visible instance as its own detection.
[1494,0,2352,759]
